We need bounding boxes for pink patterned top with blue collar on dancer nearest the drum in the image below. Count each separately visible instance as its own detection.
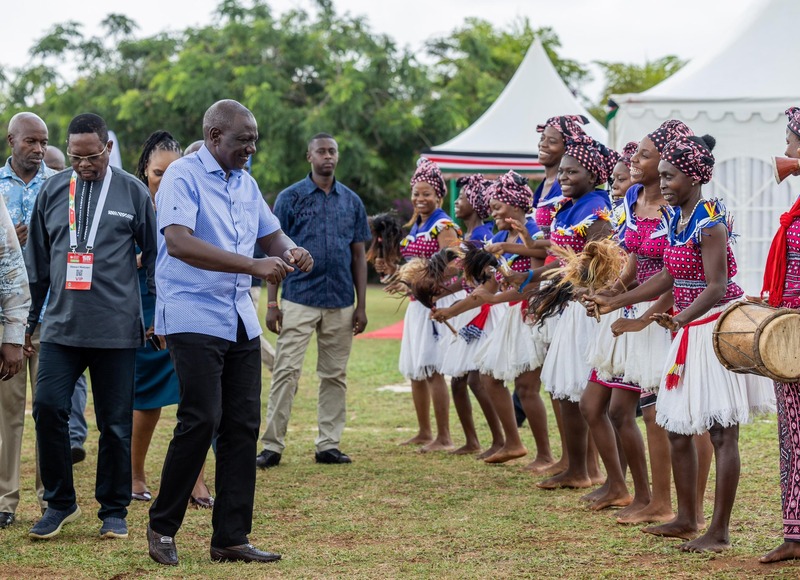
[663,200,744,312]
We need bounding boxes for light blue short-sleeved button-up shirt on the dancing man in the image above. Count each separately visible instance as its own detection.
[155,145,280,342]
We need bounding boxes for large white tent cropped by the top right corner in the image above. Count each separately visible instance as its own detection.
[609,0,800,293]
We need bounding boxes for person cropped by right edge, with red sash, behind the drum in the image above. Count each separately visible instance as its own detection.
[759,107,800,564]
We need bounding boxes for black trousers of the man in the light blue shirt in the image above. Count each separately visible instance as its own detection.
[150,320,261,548]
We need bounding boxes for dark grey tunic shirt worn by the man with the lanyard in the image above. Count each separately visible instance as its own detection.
[25,168,156,348]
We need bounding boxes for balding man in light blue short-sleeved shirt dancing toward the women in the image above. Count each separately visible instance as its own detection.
[147,100,314,566]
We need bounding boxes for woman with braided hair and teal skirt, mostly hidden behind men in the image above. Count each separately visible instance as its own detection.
[131,131,214,508]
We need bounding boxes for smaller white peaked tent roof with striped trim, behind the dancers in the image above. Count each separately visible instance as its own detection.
[424,39,608,174]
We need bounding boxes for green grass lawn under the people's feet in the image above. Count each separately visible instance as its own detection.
[0,288,800,580]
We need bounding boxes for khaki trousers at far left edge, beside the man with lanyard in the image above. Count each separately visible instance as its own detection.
[0,328,47,513]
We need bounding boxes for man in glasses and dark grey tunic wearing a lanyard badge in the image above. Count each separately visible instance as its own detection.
[25,113,156,539]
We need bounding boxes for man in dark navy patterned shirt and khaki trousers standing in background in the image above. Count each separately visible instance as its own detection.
[256,133,370,468]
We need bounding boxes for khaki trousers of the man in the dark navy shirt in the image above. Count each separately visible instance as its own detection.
[261,300,354,453]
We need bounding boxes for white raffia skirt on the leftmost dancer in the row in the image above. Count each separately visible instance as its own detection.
[399,290,466,381]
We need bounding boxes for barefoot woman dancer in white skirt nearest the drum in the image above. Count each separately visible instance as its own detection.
[592,136,774,552]
